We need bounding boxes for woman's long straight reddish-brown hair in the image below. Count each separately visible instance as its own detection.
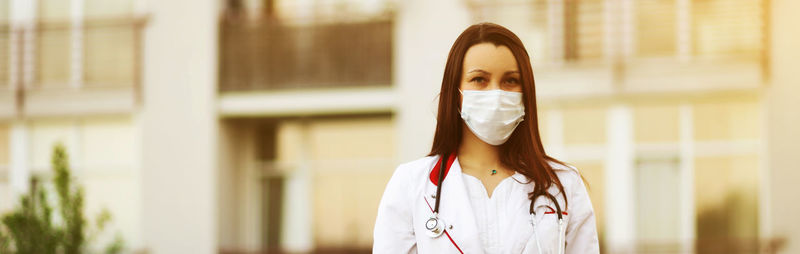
[429,23,567,210]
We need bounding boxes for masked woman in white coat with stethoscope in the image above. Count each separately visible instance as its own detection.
[373,23,599,253]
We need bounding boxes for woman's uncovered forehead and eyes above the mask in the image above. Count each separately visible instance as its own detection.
[459,42,522,92]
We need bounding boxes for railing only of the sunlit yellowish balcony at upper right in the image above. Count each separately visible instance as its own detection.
[464,0,769,62]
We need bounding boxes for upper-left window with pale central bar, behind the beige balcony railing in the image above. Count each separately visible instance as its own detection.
[35,0,139,87]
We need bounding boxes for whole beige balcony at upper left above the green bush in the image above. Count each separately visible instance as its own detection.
[0,18,145,118]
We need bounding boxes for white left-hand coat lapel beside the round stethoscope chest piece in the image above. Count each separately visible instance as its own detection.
[433,158,483,253]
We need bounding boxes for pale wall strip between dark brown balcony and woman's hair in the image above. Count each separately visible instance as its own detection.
[393,0,470,161]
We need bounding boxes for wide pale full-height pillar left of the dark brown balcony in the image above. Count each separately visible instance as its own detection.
[140,0,217,254]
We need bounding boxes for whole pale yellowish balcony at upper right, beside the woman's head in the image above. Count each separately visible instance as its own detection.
[464,0,770,99]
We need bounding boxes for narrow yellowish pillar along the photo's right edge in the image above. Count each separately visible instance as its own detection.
[761,0,800,253]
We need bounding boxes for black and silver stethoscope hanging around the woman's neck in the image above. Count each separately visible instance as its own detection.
[425,154,564,254]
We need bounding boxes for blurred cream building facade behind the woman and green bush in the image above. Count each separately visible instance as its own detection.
[0,0,800,253]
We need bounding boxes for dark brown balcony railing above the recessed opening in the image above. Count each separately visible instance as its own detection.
[219,19,392,91]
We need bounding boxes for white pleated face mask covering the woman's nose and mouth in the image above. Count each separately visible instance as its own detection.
[461,90,525,146]
